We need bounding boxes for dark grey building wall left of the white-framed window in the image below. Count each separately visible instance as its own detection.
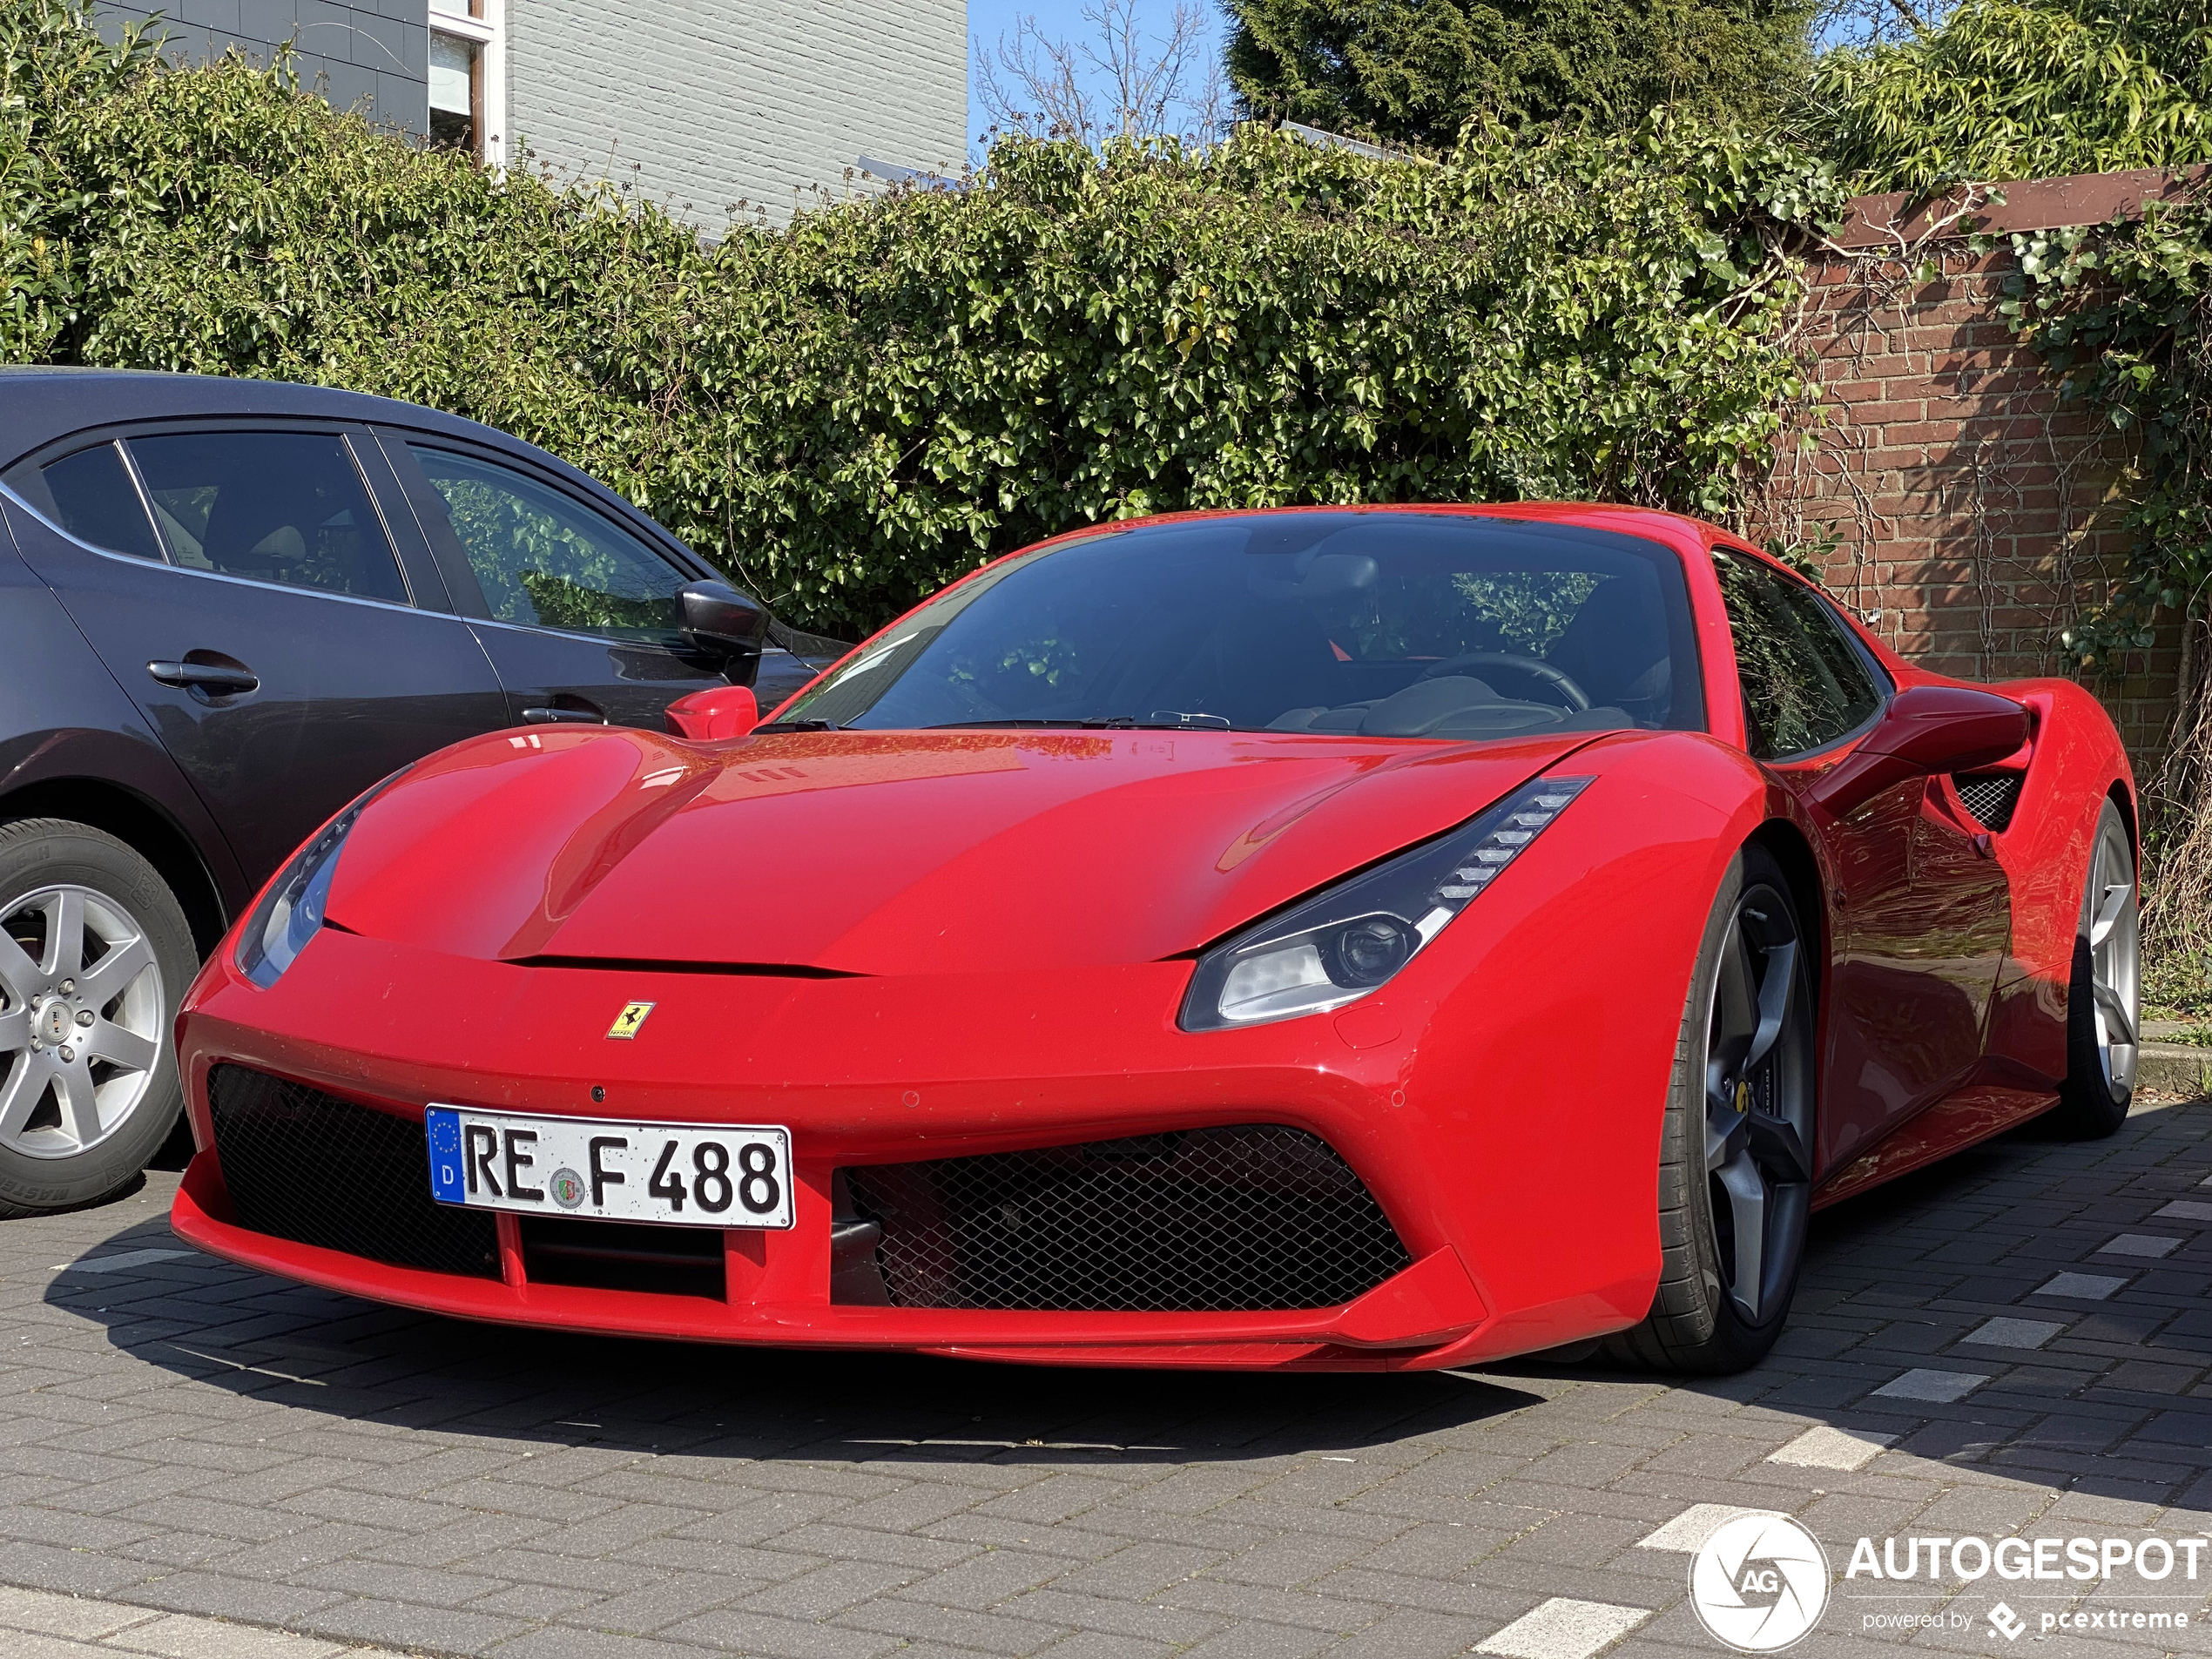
[99,0,429,132]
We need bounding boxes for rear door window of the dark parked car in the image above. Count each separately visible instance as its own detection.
[128,431,407,604]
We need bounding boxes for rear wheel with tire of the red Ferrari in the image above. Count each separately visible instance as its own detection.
[2051,800,2143,1142]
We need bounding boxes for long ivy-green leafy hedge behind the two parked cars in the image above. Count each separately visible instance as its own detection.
[0,0,1838,632]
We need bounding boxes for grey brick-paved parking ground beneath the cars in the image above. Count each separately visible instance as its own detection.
[0,1102,2212,1659]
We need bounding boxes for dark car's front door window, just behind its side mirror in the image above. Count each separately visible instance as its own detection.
[407,445,692,646]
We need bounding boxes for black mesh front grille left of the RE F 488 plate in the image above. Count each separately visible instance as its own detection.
[208,1066,500,1278]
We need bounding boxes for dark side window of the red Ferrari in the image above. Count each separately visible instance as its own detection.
[1712,549,1883,761]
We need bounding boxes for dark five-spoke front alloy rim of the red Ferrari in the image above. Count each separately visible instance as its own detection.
[1705,885,1811,1325]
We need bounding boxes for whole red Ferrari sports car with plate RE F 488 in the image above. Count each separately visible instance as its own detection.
[175,507,2137,1372]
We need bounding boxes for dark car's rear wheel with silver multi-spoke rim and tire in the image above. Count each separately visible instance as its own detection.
[0,819,199,1217]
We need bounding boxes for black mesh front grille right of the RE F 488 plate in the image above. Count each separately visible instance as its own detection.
[832,1123,1412,1312]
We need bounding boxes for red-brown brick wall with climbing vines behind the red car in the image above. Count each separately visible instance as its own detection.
[1757,175,2181,770]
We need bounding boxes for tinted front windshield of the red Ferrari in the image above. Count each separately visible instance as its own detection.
[777,511,1703,741]
